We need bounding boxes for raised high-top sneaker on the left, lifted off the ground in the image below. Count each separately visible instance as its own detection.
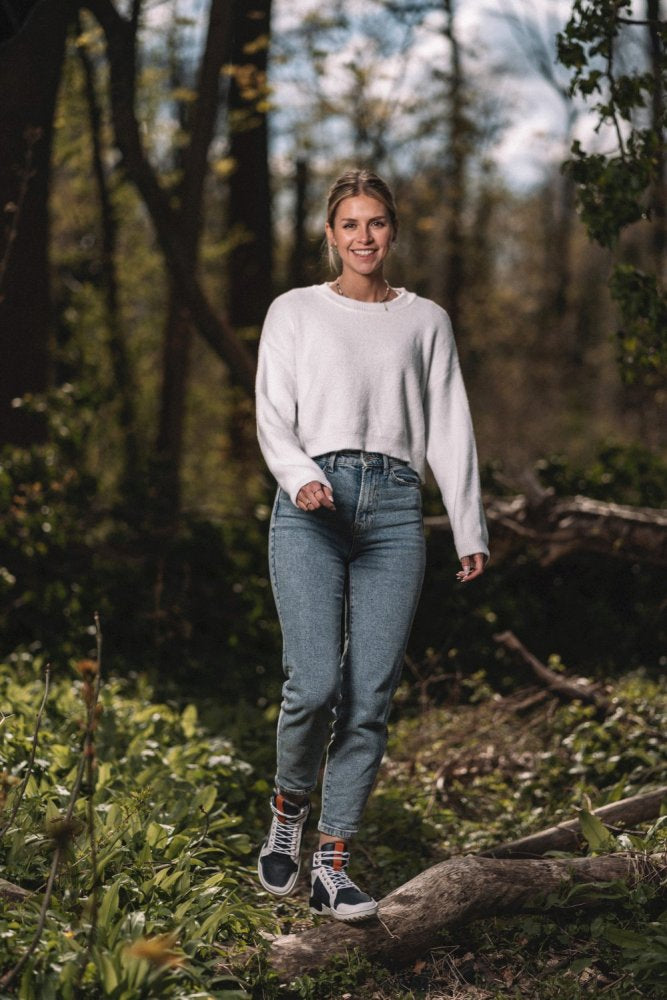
[257,792,310,896]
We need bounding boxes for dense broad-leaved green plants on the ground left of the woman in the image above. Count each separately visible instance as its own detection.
[0,654,272,1000]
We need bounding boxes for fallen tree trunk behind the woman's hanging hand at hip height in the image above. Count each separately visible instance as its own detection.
[424,493,667,566]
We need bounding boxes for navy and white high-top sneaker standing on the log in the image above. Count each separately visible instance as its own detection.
[310,840,378,921]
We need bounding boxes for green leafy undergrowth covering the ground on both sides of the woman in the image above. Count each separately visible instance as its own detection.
[0,653,667,1000]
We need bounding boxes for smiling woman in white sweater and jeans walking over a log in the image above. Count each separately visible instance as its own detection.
[257,170,488,921]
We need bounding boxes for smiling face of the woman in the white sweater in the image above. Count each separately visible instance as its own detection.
[326,194,394,275]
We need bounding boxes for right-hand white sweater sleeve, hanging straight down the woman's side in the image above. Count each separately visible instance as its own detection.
[424,312,489,558]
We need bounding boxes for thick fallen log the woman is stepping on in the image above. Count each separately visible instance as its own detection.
[269,854,667,981]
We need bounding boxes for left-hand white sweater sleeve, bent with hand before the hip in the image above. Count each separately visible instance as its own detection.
[255,292,331,506]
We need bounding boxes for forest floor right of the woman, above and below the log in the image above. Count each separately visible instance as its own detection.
[226,673,667,1000]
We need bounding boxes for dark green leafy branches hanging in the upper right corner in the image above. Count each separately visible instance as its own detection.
[558,0,667,388]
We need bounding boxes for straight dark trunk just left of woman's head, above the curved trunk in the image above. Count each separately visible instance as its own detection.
[228,0,273,327]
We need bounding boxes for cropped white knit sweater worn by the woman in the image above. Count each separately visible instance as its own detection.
[257,284,488,557]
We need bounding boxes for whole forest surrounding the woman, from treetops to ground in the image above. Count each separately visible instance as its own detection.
[0,0,667,1000]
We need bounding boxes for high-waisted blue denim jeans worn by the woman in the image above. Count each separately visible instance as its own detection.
[269,451,425,839]
